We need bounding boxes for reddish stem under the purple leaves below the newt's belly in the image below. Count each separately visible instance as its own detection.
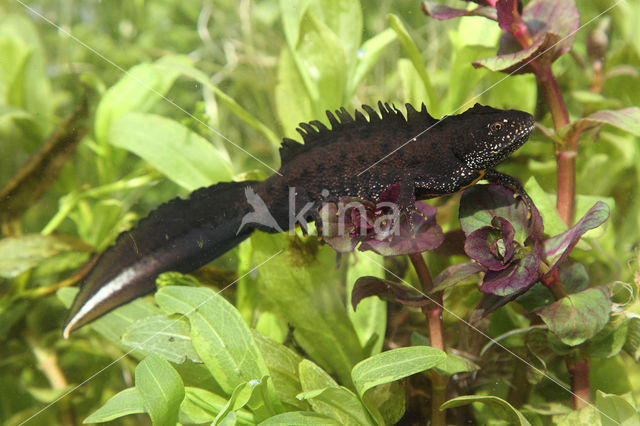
[409,253,449,426]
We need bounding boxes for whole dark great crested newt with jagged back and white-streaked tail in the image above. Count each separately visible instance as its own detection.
[63,102,534,337]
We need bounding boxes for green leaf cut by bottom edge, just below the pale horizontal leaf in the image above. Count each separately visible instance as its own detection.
[298,386,374,425]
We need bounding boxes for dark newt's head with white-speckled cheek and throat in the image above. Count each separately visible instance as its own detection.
[445,104,535,170]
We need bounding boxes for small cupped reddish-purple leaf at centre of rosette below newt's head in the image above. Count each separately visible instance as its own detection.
[464,217,518,271]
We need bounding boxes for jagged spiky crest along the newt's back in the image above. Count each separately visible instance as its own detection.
[280,102,438,164]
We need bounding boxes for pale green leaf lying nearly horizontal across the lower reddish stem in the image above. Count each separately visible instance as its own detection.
[351,346,447,396]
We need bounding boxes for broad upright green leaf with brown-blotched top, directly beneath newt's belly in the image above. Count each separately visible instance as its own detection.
[251,232,362,384]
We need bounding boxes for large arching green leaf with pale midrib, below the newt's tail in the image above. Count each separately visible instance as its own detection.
[156,286,279,418]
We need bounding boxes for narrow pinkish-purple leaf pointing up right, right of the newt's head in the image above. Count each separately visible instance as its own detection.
[544,201,609,275]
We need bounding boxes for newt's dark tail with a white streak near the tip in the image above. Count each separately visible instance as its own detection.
[63,181,260,338]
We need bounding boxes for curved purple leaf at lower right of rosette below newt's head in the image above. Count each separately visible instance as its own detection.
[479,241,542,296]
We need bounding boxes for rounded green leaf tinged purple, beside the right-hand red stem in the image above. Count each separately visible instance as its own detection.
[538,286,611,346]
